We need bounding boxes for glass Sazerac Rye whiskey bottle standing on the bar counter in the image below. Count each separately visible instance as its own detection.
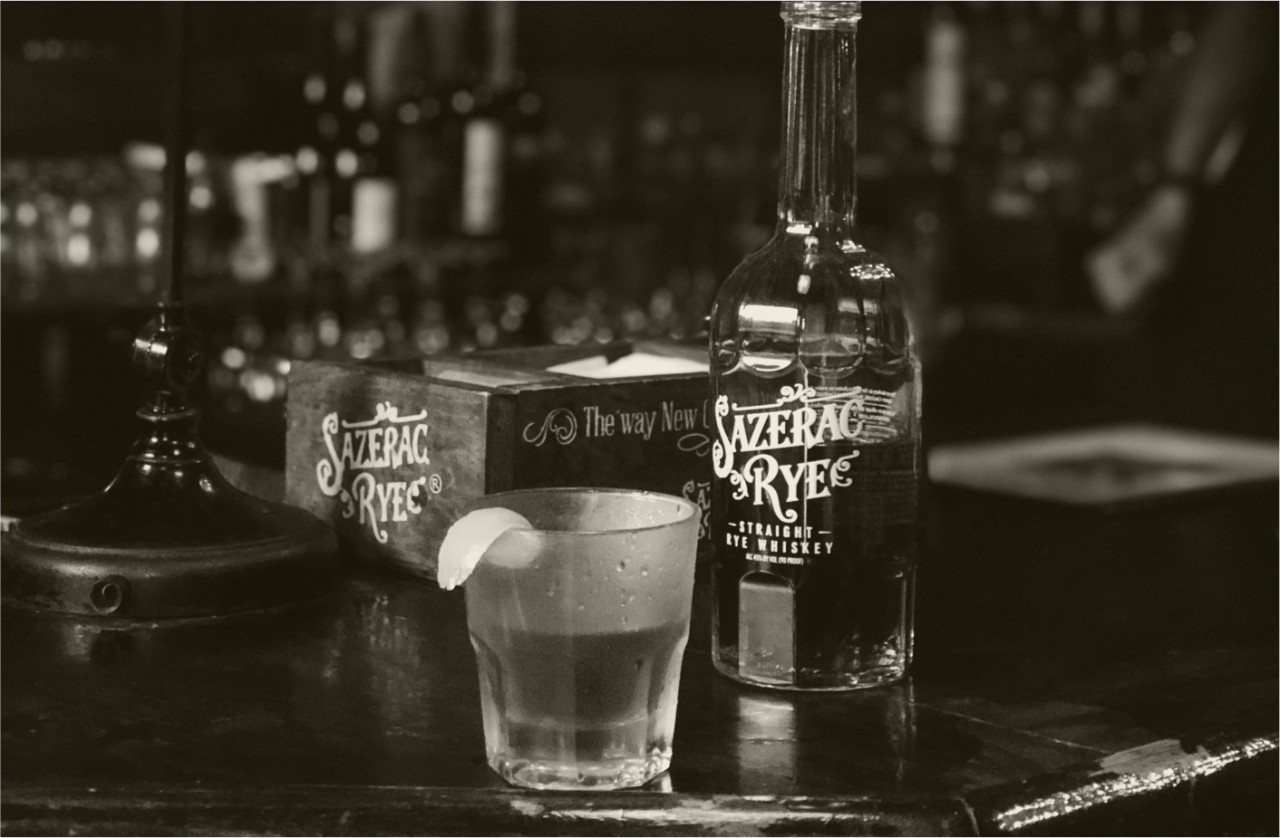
[710,3,922,690]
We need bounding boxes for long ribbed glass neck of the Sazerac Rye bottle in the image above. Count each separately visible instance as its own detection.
[778,14,858,237]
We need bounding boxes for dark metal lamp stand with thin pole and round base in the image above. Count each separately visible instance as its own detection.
[0,3,337,621]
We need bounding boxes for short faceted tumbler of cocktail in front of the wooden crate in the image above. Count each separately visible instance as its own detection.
[465,489,699,789]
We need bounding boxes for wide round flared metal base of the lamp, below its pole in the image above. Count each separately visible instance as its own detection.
[0,409,338,621]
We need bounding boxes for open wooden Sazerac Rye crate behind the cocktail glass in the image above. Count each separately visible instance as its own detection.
[285,343,712,578]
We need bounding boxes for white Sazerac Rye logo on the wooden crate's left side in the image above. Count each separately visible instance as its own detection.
[316,402,442,544]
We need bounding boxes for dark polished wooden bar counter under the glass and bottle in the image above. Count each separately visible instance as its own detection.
[0,475,1277,834]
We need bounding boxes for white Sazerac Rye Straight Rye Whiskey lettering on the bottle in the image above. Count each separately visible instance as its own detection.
[712,385,915,565]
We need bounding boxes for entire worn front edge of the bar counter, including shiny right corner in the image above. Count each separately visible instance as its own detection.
[0,731,1280,835]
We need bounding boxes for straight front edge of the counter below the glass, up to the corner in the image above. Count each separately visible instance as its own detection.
[0,783,977,835]
